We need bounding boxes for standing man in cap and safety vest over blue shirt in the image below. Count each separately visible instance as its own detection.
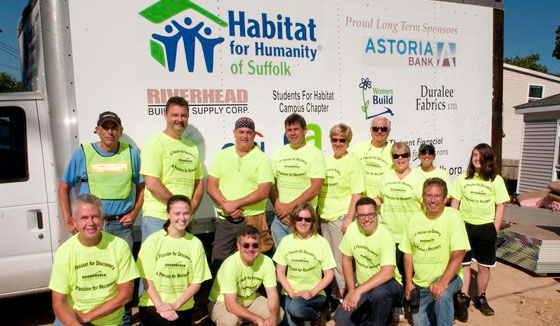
[58,111,144,326]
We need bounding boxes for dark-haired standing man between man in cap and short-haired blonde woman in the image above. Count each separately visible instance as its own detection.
[270,113,325,247]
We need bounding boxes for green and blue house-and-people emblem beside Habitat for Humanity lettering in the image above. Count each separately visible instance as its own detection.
[140,0,228,73]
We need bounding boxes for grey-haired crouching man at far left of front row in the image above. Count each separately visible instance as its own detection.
[49,194,139,326]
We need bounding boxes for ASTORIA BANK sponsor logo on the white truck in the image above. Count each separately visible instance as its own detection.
[365,37,457,67]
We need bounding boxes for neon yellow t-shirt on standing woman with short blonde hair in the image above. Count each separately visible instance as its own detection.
[319,153,365,221]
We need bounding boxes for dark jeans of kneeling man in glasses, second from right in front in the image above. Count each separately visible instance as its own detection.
[334,279,403,326]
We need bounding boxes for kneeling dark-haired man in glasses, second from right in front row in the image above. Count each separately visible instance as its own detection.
[334,197,403,326]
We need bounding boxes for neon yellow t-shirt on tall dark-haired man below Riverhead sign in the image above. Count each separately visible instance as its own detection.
[140,132,204,220]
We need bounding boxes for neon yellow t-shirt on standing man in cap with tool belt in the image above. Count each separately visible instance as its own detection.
[208,146,274,219]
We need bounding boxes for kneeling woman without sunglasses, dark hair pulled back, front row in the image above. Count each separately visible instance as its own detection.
[138,195,211,326]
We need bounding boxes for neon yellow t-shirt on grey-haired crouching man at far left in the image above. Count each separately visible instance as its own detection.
[49,231,139,325]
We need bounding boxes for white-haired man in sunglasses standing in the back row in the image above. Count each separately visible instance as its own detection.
[352,116,392,198]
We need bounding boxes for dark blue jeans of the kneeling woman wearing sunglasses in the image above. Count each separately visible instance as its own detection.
[280,295,327,326]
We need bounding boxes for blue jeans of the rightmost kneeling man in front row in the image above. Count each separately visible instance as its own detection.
[412,275,463,326]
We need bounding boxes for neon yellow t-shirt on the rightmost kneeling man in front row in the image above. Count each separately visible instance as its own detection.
[399,207,471,287]
